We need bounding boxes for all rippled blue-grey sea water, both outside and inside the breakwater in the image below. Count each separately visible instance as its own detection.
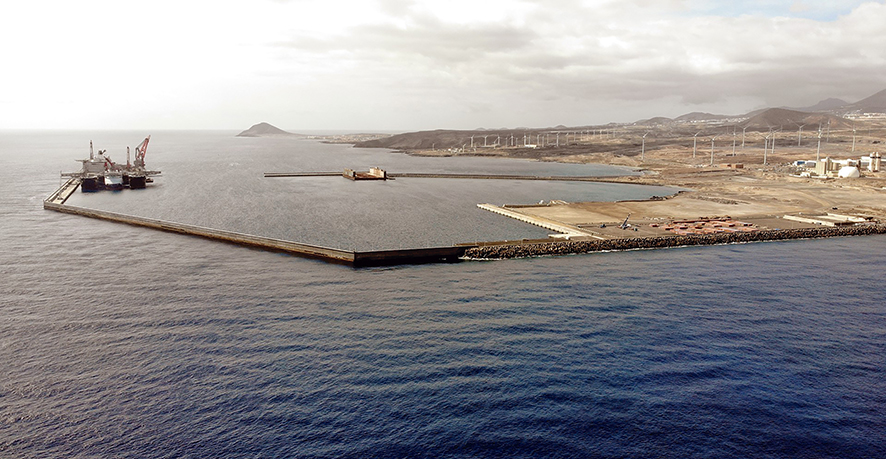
[0,132,886,458]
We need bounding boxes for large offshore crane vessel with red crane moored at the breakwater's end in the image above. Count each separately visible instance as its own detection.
[62,136,160,193]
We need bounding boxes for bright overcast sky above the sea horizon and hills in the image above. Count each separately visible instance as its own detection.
[0,0,886,132]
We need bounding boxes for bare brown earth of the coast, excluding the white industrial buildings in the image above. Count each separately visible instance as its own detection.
[358,118,886,239]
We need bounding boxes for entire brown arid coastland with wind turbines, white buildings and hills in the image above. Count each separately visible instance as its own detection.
[342,102,886,258]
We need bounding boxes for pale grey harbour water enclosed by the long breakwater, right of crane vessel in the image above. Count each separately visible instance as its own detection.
[57,135,673,251]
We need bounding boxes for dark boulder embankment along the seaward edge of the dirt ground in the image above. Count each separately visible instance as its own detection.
[464,225,886,259]
